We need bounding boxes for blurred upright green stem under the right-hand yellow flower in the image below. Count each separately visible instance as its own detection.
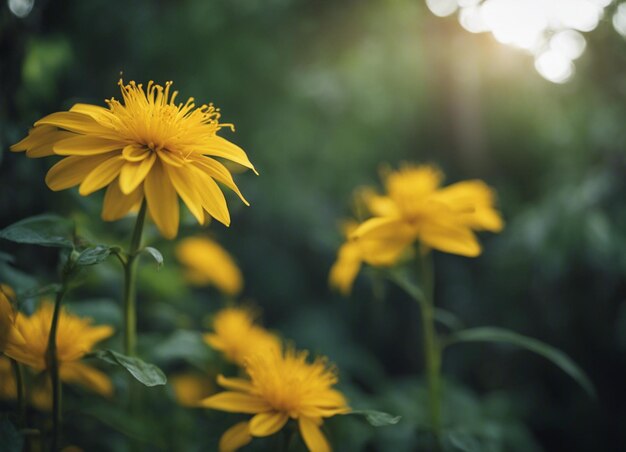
[420,252,442,449]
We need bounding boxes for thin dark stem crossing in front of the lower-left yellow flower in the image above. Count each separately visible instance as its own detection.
[47,280,69,452]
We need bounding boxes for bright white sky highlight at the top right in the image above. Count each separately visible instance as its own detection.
[426,0,612,83]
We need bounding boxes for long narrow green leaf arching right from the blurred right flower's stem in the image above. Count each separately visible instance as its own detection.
[448,327,596,397]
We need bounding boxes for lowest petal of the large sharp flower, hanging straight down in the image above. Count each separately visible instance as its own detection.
[144,161,179,239]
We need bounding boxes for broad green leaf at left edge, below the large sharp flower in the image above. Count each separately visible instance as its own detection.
[0,214,74,248]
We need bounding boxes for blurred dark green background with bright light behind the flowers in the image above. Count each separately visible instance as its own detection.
[0,0,626,451]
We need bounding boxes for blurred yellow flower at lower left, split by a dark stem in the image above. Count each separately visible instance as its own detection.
[5,302,113,396]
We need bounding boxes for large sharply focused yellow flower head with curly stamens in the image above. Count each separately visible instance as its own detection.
[11,80,254,238]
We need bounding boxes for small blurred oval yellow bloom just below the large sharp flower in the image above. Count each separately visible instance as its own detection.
[176,237,243,297]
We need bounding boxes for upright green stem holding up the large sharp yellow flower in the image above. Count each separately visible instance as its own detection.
[124,199,146,356]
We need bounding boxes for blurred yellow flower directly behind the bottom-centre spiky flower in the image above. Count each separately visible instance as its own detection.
[204,307,281,366]
